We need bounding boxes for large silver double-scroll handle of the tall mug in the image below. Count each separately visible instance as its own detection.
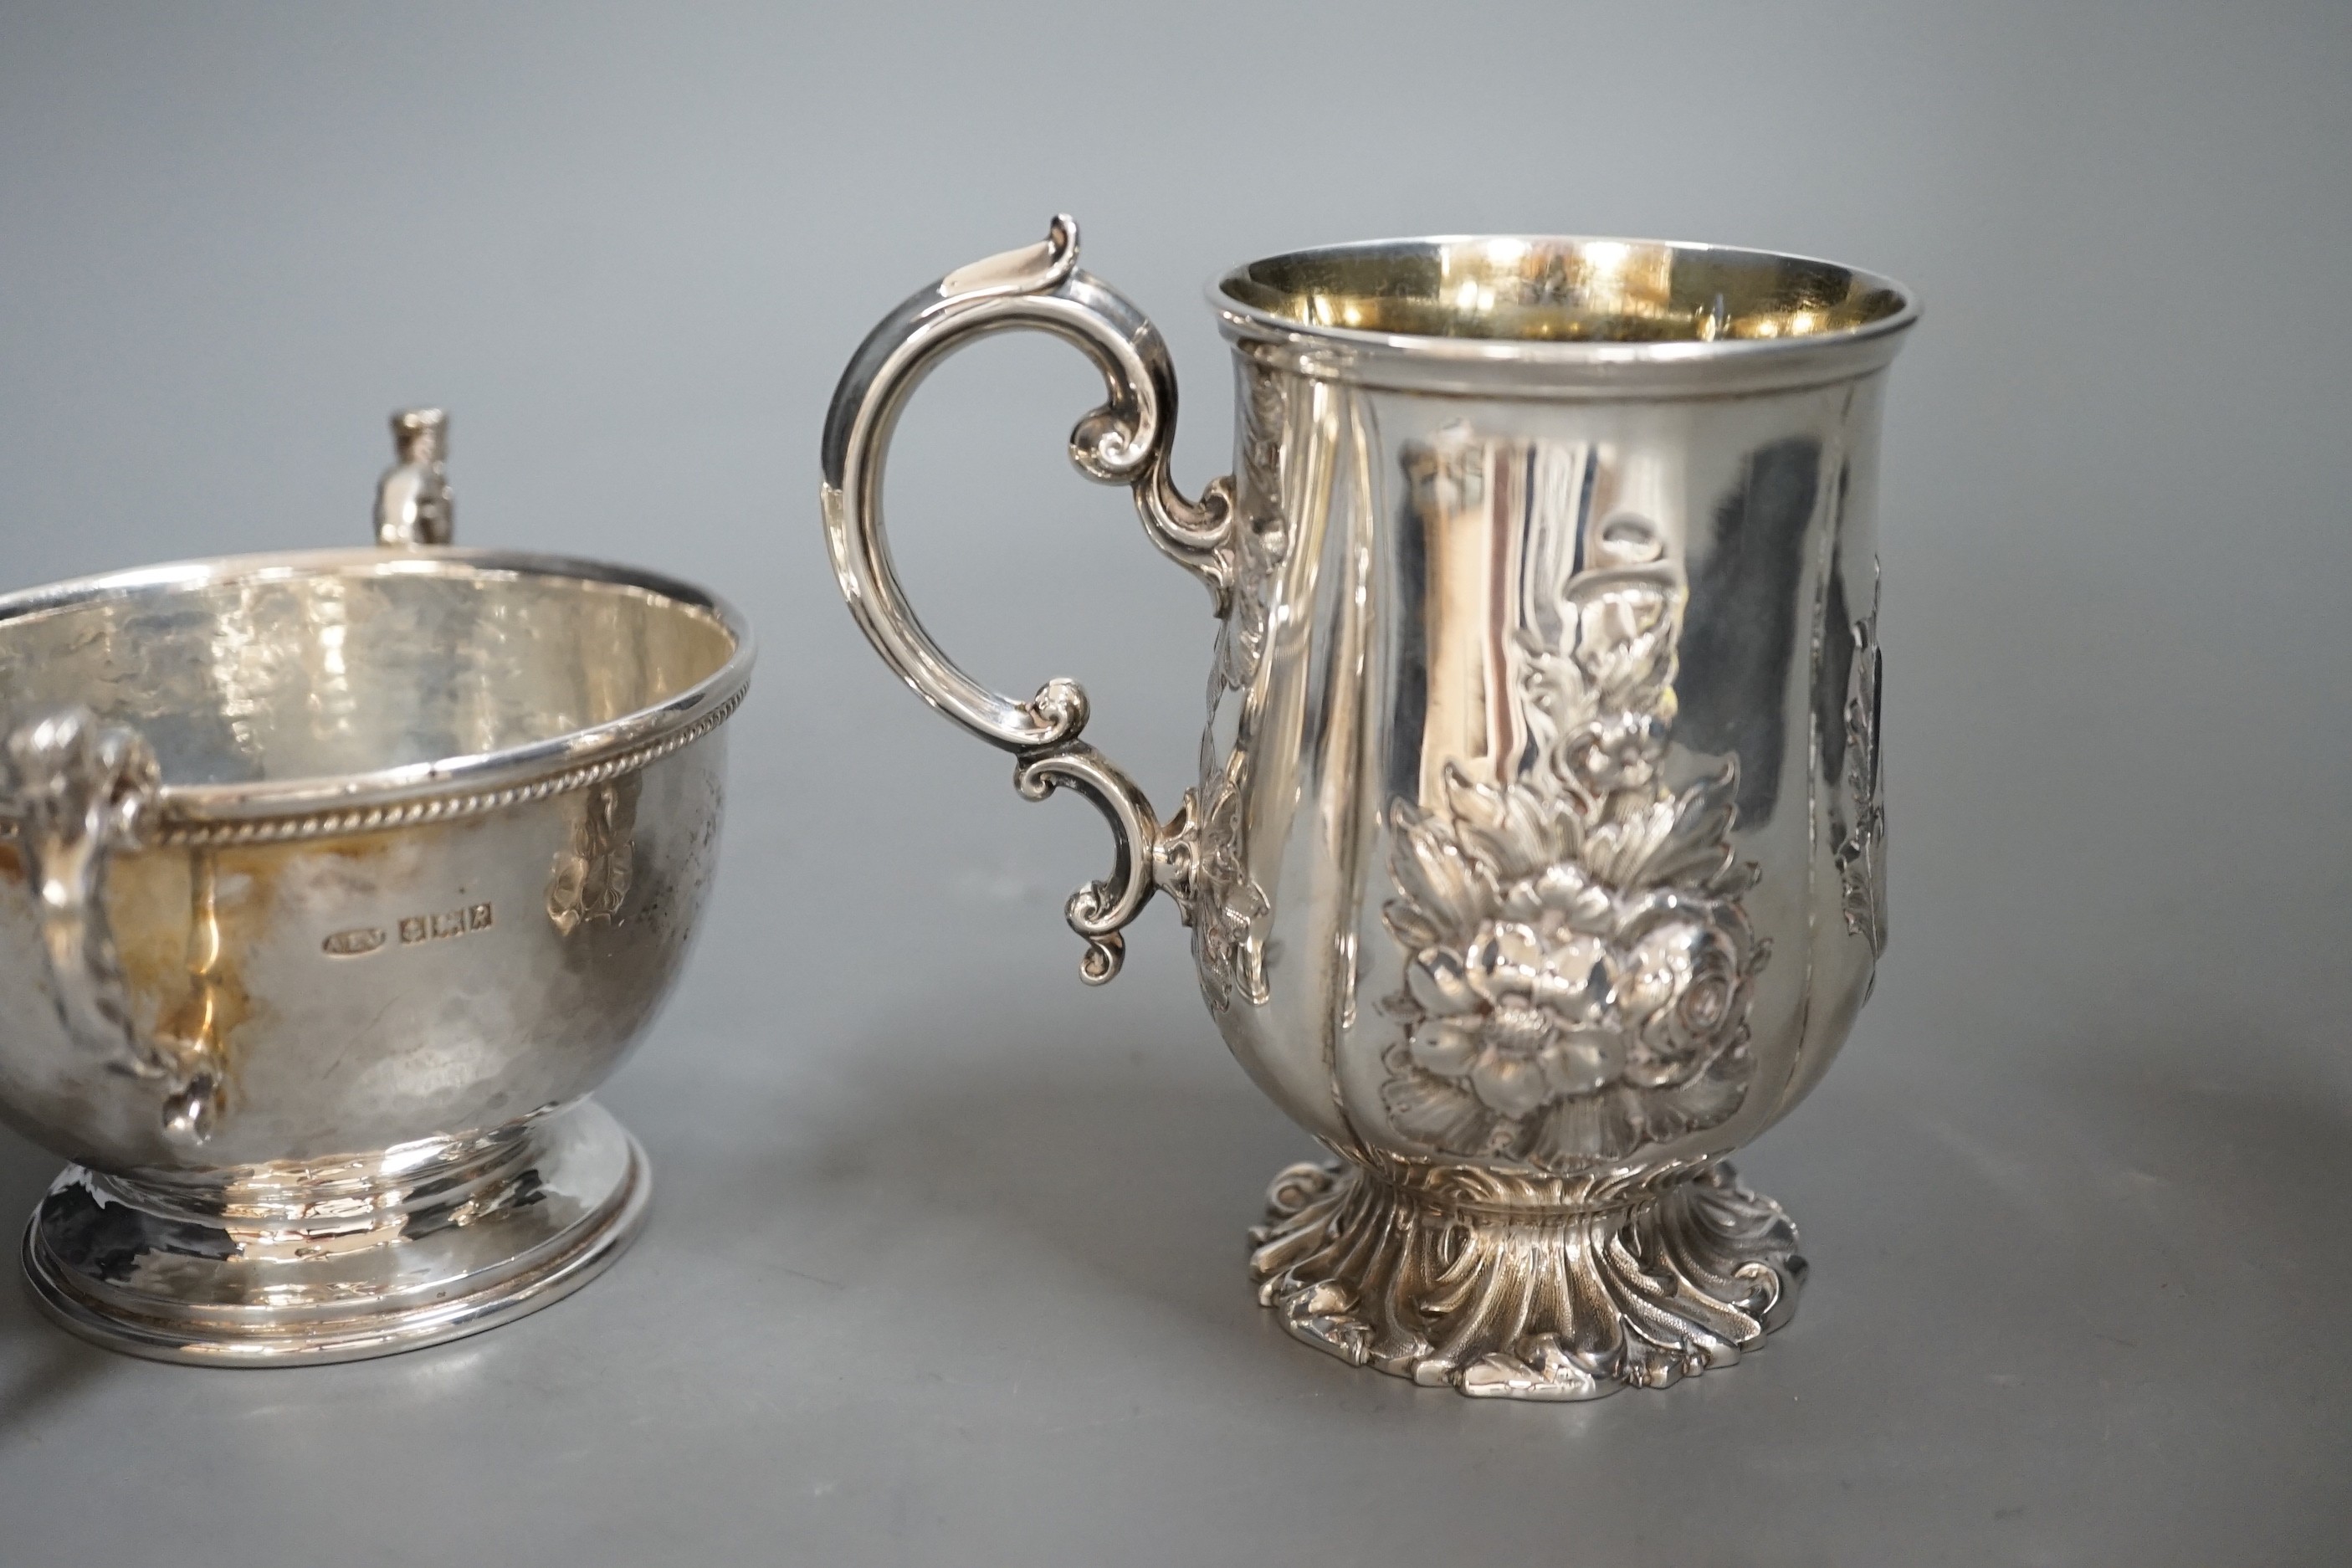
[821,214,1232,985]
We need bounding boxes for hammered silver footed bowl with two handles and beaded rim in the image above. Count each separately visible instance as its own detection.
[0,412,753,1366]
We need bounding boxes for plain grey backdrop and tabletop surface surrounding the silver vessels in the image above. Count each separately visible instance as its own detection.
[0,0,2352,1568]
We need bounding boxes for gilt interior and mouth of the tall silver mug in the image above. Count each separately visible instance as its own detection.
[1212,235,1917,360]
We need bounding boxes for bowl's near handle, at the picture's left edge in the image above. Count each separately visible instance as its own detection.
[0,708,217,1142]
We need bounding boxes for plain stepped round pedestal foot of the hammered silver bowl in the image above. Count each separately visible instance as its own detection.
[23,1100,647,1366]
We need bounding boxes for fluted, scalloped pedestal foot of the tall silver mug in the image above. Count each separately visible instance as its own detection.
[1249,1164,1804,1399]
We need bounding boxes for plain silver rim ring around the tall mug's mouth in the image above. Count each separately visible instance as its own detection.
[1207,233,1919,381]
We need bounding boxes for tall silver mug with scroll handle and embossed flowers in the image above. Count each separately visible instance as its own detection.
[823,218,1917,1399]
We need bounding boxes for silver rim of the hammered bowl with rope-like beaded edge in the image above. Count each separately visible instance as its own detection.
[0,546,757,842]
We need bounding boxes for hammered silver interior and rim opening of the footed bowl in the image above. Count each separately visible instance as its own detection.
[0,550,753,818]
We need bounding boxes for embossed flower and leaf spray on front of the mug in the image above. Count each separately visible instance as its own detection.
[1383,517,1769,1173]
